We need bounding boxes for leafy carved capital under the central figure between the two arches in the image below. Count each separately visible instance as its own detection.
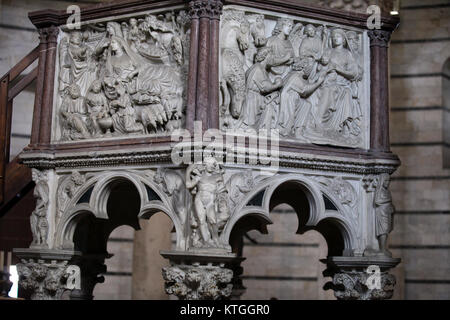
[162,265,233,300]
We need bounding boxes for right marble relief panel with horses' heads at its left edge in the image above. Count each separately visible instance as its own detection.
[220,8,368,147]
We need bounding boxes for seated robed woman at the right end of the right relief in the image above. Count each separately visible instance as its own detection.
[318,29,362,136]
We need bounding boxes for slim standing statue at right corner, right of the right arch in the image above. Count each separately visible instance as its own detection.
[373,173,395,257]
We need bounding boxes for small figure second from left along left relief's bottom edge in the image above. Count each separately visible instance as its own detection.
[85,80,110,136]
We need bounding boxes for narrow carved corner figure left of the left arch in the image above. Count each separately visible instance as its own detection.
[30,169,49,248]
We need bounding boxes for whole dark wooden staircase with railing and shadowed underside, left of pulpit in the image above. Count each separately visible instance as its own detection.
[0,46,39,255]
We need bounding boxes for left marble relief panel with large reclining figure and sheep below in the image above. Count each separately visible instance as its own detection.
[55,11,190,141]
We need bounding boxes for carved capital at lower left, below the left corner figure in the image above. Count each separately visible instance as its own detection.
[17,259,79,300]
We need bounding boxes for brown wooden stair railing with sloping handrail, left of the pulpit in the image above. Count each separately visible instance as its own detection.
[0,46,39,209]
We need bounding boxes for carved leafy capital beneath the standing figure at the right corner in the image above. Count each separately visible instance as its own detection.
[325,271,396,300]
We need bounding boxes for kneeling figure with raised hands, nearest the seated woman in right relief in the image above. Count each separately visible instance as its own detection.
[278,57,326,137]
